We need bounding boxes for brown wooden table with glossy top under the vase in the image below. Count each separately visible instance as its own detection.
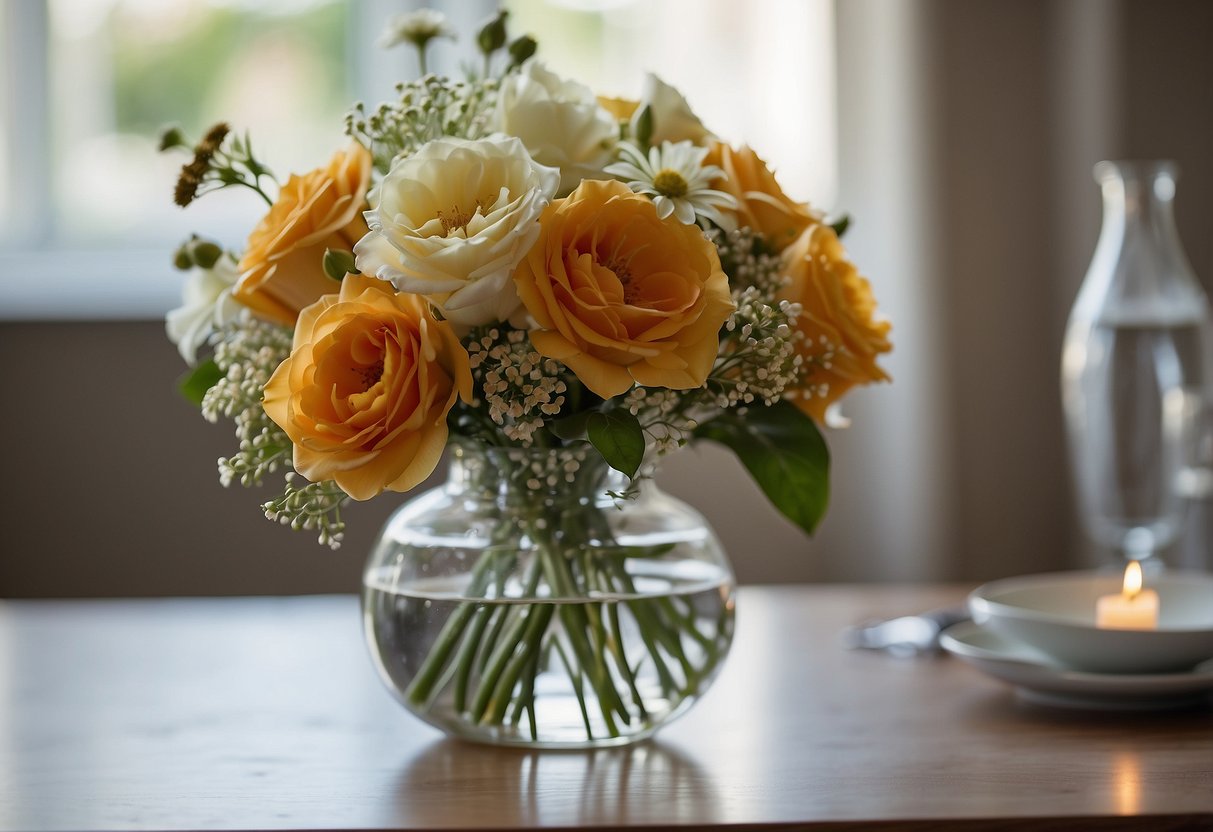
[0,586,1213,832]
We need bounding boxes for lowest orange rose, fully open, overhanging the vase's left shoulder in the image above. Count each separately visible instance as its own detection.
[263,274,472,500]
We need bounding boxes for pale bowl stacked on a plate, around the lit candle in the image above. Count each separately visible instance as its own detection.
[940,572,1213,710]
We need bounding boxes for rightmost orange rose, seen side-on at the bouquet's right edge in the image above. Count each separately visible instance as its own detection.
[781,224,893,422]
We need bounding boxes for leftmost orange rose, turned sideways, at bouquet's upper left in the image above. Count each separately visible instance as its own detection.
[233,144,371,324]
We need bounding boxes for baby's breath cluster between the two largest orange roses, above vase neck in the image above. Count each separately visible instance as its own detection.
[466,325,569,448]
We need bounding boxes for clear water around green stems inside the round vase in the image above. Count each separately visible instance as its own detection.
[363,553,733,747]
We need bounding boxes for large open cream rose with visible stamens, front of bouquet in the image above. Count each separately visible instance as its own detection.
[354,136,560,326]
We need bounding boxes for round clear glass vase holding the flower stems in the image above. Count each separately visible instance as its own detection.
[363,443,735,748]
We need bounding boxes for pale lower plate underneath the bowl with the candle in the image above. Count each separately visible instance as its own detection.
[940,621,1213,711]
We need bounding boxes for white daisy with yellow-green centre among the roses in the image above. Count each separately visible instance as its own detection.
[605,142,738,230]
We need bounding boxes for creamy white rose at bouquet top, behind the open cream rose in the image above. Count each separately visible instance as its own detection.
[494,59,619,194]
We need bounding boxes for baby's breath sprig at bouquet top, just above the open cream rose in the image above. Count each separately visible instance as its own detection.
[346,75,499,173]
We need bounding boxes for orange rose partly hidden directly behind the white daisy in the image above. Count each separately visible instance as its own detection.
[704,141,821,250]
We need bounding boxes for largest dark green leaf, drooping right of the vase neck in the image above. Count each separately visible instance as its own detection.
[695,401,830,535]
